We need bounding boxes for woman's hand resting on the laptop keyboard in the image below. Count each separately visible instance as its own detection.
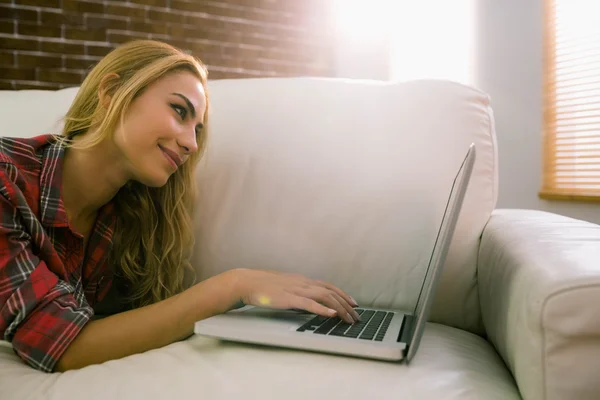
[231,269,360,323]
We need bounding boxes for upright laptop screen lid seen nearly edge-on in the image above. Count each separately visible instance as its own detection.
[406,144,475,361]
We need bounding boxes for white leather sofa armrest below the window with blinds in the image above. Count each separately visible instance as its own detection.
[477,210,600,400]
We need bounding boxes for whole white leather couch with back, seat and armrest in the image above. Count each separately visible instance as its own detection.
[0,78,600,400]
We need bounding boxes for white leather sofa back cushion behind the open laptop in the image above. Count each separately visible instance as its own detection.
[194,78,497,333]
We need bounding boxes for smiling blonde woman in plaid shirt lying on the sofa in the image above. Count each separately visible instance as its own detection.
[0,41,358,372]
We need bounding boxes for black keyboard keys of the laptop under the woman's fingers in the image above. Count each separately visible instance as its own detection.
[297,308,394,342]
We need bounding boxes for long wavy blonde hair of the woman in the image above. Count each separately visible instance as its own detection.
[59,40,208,306]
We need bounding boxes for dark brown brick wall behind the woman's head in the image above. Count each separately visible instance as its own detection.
[0,0,333,89]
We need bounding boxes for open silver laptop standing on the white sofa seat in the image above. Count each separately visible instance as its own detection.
[194,144,475,363]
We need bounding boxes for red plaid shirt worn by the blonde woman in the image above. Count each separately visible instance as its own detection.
[0,135,115,372]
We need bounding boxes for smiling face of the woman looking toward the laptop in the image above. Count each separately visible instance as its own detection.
[114,71,206,187]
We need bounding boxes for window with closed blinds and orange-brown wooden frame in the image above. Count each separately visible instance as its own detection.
[540,0,600,201]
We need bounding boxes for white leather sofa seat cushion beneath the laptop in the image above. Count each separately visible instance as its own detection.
[0,323,520,400]
